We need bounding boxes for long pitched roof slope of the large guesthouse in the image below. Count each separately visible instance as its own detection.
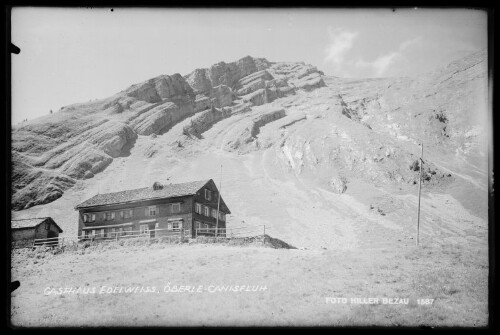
[75,179,211,209]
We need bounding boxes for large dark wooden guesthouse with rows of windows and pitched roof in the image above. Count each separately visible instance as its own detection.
[75,179,231,238]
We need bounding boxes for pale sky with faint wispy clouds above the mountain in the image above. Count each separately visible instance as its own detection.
[11,7,487,124]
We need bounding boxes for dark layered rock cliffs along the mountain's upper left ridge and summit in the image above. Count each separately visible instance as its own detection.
[12,56,325,210]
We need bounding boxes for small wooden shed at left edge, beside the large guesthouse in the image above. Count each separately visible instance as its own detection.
[11,217,63,247]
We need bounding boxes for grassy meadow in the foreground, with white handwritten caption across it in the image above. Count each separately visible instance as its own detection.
[11,244,488,327]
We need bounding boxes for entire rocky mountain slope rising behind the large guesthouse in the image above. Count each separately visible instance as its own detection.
[12,52,488,252]
